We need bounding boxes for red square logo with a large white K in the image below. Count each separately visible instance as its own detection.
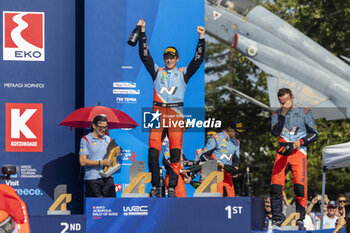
[6,103,43,152]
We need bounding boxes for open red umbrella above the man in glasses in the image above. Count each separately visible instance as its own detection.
[59,106,138,129]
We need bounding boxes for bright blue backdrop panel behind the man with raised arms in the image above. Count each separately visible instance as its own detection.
[85,0,204,197]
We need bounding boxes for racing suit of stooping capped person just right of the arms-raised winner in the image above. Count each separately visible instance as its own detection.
[199,132,240,197]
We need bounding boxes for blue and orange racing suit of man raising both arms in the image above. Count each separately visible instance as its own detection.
[139,32,205,191]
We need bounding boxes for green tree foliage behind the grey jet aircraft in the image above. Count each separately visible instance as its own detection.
[205,0,350,199]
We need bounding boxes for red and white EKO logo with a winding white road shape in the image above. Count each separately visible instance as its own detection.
[3,11,45,61]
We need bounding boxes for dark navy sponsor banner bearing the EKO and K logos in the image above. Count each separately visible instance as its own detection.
[0,0,79,215]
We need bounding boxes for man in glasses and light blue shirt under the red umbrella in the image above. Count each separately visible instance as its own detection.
[79,115,116,197]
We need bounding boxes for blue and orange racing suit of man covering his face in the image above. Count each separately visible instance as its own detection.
[270,106,318,222]
